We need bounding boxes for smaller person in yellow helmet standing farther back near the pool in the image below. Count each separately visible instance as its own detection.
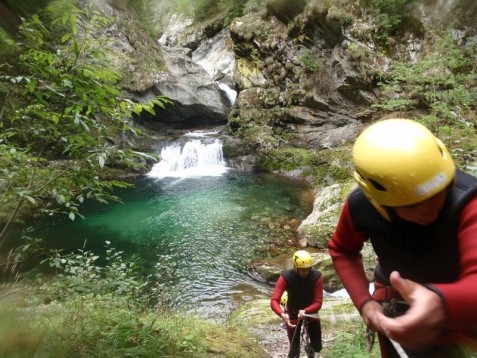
[270,250,323,358]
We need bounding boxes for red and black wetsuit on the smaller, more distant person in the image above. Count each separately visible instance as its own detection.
[270,268,323,357]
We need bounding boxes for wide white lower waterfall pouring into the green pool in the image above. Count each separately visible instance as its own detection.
[147,133,228,179]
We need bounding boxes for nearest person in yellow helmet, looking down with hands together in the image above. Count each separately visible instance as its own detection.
[328,119,477,358]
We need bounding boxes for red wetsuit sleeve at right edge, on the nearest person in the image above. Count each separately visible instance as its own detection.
[433,198,477,329]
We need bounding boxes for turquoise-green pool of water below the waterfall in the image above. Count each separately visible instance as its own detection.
[11,171,311,314]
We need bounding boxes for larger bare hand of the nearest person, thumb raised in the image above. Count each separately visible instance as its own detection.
[380,271,445,349]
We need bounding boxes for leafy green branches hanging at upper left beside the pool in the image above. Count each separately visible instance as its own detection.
[0,1,167,242]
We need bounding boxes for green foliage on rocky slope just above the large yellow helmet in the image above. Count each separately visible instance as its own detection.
[377,35,477,148]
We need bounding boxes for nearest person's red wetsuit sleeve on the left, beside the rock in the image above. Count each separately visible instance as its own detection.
[328,201,372,311]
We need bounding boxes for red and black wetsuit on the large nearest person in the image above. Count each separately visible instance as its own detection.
[328,171,477,356]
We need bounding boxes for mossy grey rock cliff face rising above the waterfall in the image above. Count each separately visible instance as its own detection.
[124,0,477,154]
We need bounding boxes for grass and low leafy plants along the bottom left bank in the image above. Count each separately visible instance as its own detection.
[0,242,265,358]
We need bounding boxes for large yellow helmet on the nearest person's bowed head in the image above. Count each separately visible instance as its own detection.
[353,119,455,220]
